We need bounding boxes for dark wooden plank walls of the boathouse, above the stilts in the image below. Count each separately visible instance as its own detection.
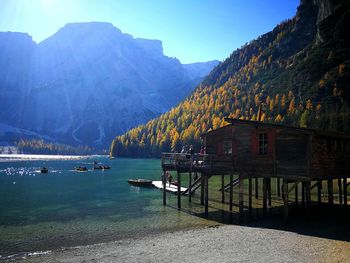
[204,119,350,180]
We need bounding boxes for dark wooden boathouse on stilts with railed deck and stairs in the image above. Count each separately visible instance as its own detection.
[162,118,350,222]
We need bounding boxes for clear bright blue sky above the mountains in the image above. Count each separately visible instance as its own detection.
[0,0,299,63]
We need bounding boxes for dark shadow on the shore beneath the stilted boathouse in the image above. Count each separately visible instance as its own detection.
[181,204,350,241]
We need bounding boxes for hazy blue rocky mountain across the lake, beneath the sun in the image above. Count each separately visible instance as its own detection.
[0,22,218,148]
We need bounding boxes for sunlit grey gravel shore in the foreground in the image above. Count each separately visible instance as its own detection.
[19,225,350,263]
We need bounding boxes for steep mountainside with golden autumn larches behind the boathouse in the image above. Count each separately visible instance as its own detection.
[110,0,350,157]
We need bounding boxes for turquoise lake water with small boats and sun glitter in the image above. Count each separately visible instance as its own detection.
[0,157,215,259]
